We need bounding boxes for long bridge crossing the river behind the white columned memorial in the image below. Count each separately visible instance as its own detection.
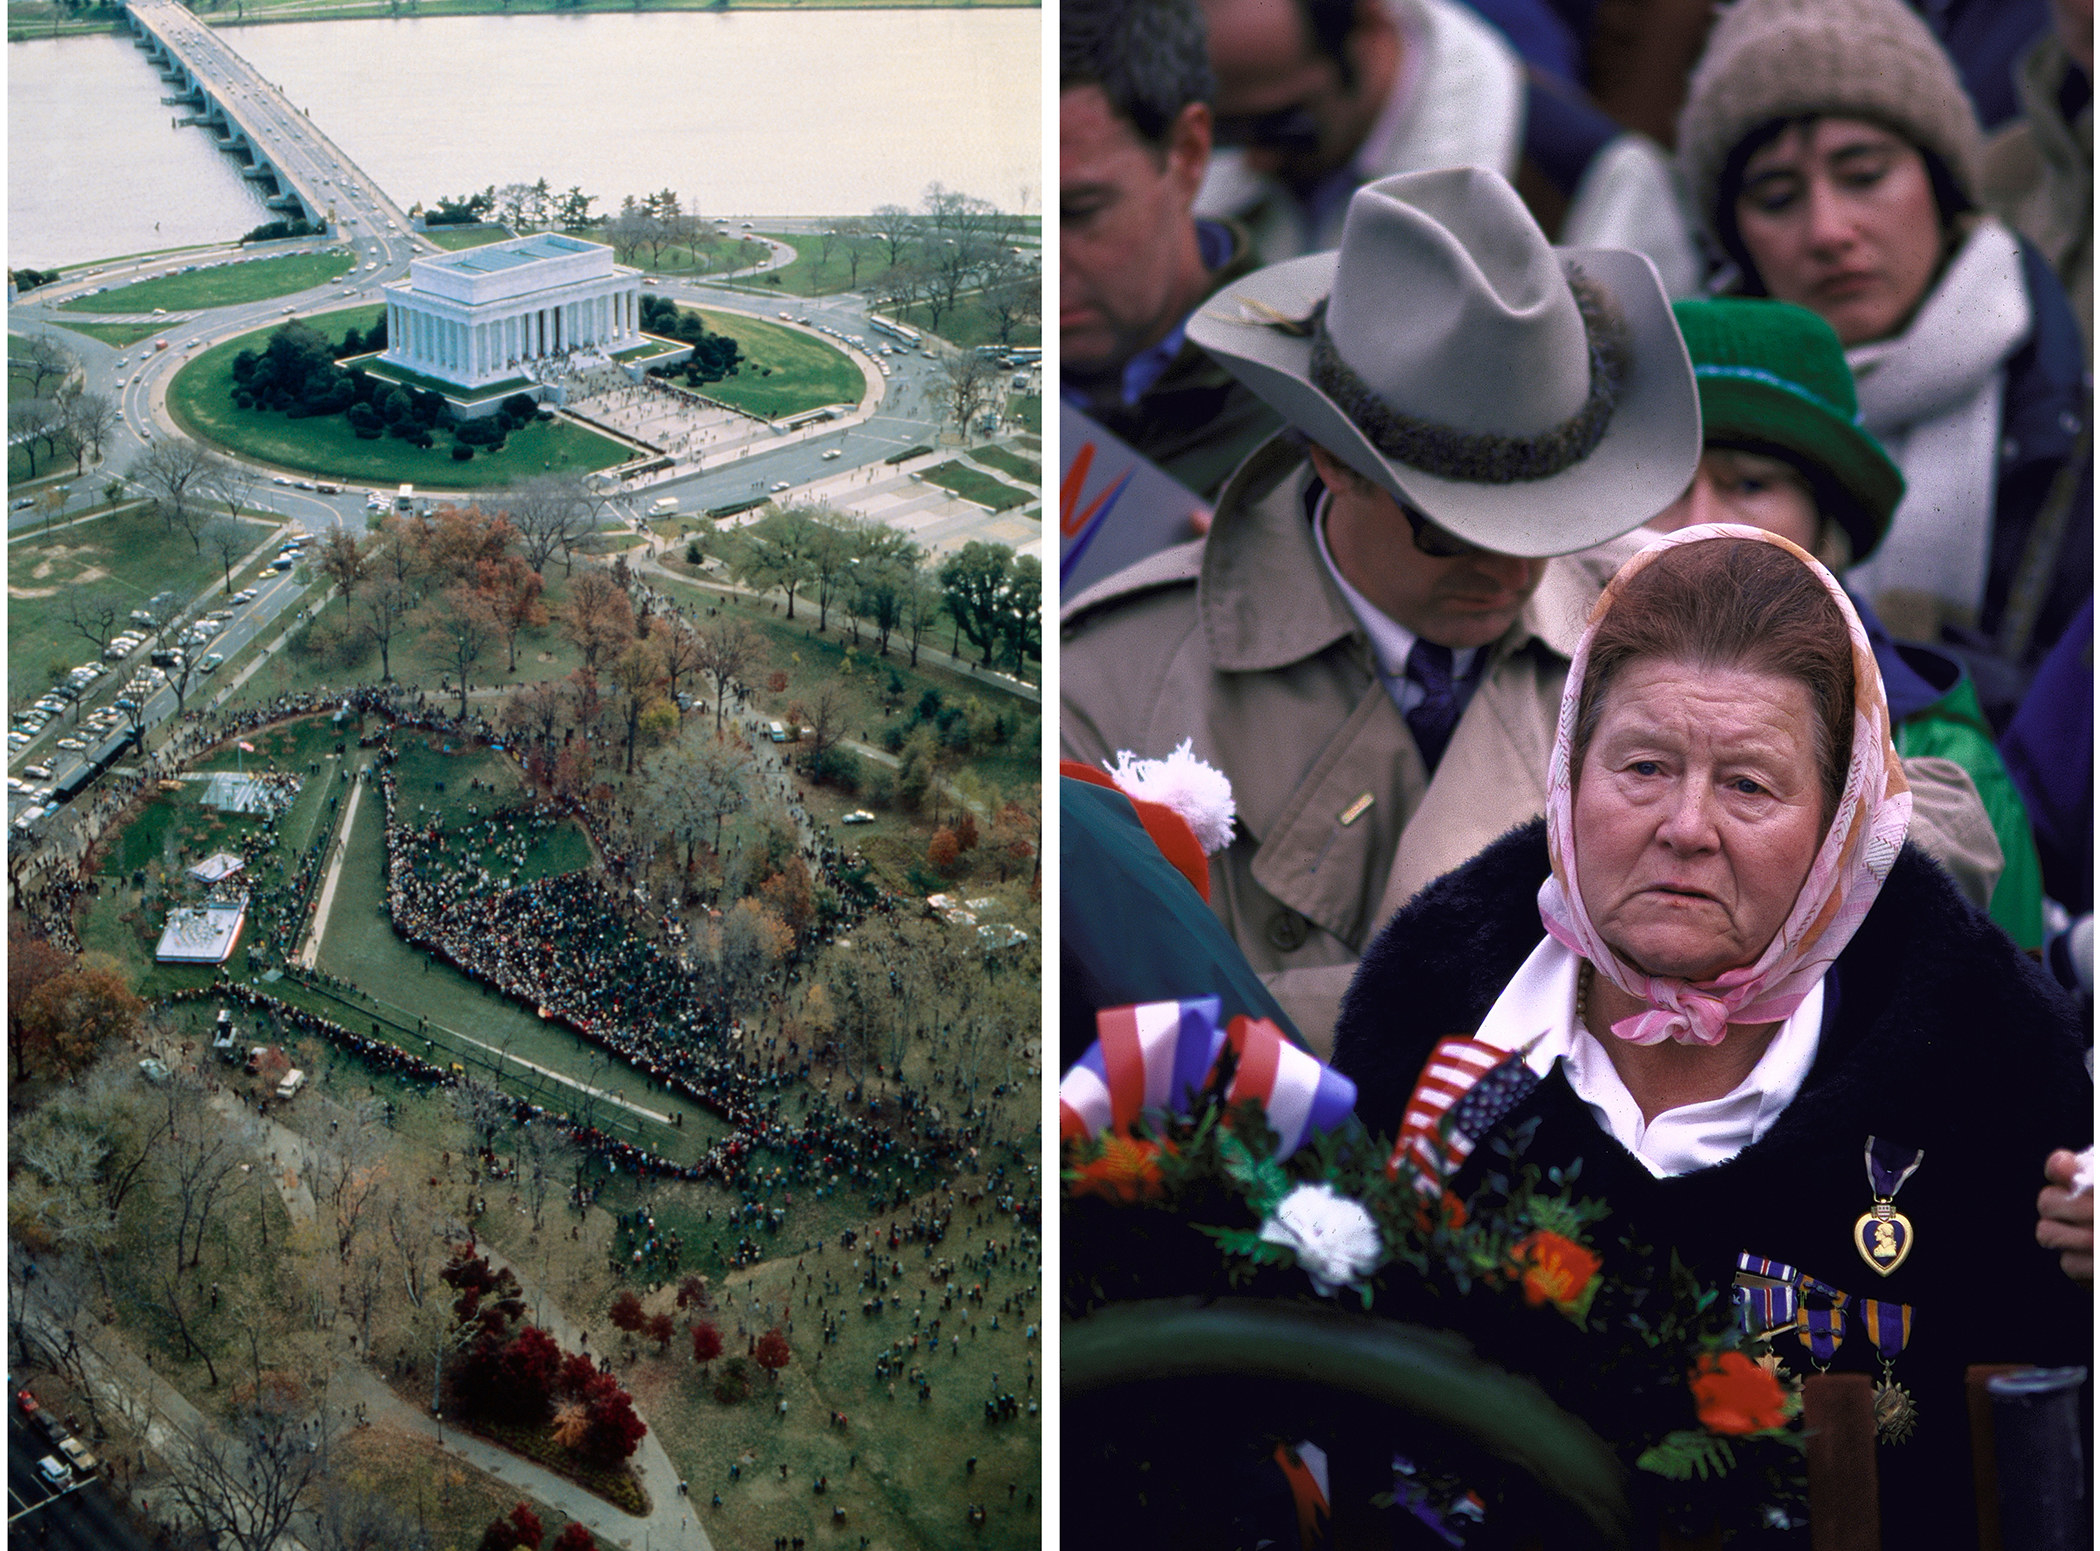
[126,0,414,245]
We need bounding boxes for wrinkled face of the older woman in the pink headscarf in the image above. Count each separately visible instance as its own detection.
[1575,657,1823,980]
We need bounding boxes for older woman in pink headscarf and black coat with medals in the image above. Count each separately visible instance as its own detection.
[1336,525,2092,1547]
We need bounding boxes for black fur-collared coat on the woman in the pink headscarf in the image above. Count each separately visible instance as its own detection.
[1334,819,2094,1547]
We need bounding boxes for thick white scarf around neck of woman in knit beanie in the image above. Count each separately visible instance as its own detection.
[1846,220,2033,638]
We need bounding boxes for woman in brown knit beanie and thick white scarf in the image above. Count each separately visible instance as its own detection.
[1678,0,2092,724]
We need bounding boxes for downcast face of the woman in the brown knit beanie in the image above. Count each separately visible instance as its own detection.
[1735,118,1940,348]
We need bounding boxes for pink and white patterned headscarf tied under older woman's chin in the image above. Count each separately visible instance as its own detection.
[1539,523,1911,1045]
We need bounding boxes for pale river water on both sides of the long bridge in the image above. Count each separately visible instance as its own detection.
[6,10,1044,269]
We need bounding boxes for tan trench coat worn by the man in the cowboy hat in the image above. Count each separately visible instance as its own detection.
[1058,437,2001,1049]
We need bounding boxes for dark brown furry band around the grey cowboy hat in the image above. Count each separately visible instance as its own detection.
[1308,264,1630,485]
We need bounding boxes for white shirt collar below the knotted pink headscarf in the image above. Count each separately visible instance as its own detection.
[1474,936,1823,1180]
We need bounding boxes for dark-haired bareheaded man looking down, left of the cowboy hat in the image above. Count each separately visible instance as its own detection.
[1058,0,1277,497]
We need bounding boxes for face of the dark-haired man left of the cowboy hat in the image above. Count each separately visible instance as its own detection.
[1058,86,1210,376]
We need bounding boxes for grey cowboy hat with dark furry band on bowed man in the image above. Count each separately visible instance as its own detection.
[1189,168,1701,556]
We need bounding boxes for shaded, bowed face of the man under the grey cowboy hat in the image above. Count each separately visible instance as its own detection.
[1313,447,1546,651]
